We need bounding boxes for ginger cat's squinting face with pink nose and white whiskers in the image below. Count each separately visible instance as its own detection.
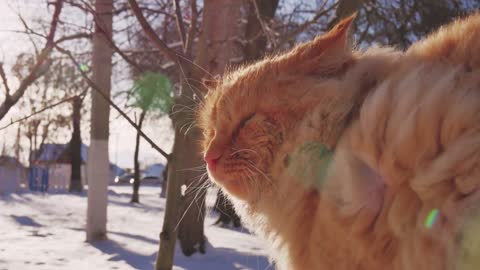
[197,70,288,199]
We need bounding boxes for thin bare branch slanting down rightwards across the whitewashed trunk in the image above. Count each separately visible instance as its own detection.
[55,46,170,160]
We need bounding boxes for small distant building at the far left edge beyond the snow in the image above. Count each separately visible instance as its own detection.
[0,156,27,194]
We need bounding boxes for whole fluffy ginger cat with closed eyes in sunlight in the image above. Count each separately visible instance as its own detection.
[198,15,480,270]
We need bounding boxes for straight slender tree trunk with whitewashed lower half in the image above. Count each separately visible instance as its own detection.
[86,0,113,242]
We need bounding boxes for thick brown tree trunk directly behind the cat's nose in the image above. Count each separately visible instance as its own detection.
[156,0,248,270]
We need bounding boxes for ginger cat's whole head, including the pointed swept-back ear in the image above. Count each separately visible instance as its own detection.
[198,16,354,200]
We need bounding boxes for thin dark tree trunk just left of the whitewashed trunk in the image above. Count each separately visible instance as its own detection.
[69,96,83,192]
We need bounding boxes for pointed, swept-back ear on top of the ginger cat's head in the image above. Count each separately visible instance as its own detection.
[280,13,356,76]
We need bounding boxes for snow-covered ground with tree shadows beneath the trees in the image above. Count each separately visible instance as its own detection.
[0,186,273,270]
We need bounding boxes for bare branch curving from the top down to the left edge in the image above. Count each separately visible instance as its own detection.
[0,0,63,119]
